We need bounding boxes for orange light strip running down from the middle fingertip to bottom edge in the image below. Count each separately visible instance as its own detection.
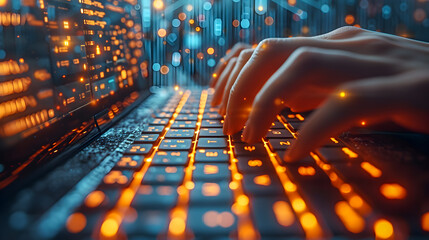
[228,135,260,239]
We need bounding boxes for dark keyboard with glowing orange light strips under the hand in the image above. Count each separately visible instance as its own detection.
[57,90,429,239]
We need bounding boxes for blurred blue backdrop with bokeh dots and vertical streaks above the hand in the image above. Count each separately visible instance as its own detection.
[146,0,429,86]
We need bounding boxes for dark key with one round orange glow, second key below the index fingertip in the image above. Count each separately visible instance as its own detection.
[243,174,284,196]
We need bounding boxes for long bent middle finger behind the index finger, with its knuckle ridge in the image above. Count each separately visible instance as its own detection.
[224,27,394,134]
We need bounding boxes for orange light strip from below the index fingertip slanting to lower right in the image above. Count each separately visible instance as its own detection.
[262,139,325,239]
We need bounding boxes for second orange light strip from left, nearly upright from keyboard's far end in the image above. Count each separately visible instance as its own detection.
[168,90,207,239]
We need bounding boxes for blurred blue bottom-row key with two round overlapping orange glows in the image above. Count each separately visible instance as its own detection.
[186,205,237,239]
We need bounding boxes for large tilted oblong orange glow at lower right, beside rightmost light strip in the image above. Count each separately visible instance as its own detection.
[335,201,365,233]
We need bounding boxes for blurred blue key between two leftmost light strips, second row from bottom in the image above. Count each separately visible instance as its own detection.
[131,185,177,210]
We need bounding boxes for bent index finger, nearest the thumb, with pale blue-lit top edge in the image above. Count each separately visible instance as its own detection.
[243,47,402,143]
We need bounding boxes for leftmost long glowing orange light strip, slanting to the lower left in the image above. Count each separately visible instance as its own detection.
[99,91,190,238]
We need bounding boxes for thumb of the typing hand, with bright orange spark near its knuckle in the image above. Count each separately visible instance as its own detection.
[285,75,416,162]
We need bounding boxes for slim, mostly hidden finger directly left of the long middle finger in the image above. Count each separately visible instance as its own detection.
[219,49,254,116]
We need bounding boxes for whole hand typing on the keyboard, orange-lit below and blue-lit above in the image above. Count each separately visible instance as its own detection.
[211,27,429,161]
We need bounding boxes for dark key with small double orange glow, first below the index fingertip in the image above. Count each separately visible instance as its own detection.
[237,156,274,174]
